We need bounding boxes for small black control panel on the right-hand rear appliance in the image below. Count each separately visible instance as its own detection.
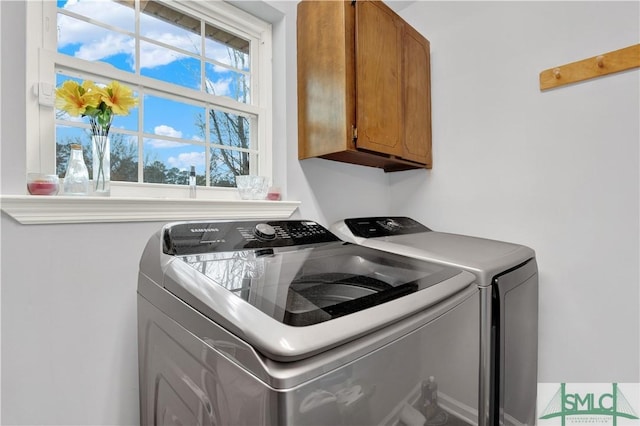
[344,216,431,238]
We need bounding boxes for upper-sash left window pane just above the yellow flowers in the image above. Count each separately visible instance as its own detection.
[58,9,135,72]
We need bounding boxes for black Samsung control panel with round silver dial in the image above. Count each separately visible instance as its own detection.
[163,220,340,255]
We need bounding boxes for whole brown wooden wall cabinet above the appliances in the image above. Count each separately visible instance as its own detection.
[297,0,431,171]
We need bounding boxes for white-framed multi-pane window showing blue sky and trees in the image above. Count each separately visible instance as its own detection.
[27,0,271,197]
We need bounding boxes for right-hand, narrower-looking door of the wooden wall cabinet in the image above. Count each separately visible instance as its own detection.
[403,25,431,167]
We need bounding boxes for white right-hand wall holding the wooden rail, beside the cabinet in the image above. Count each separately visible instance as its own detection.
[390,2,640,383]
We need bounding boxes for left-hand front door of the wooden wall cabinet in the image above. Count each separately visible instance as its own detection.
[356,1,404,156]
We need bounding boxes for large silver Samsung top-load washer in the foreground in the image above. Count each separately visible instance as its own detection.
[137,220,480,426]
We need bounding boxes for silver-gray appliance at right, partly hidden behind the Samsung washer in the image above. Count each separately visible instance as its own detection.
[330,217,538,426]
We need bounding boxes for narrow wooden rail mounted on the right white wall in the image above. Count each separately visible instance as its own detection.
[540,44,640,90]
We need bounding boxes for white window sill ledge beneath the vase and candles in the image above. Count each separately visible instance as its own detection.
[0,195,300,225]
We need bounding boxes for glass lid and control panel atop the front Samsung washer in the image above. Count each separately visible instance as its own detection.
[155,221,473,360]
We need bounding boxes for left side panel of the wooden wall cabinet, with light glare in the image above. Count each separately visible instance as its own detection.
[297,1,356,159]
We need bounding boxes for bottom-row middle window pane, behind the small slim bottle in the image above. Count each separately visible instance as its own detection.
[144,138,205,185]
